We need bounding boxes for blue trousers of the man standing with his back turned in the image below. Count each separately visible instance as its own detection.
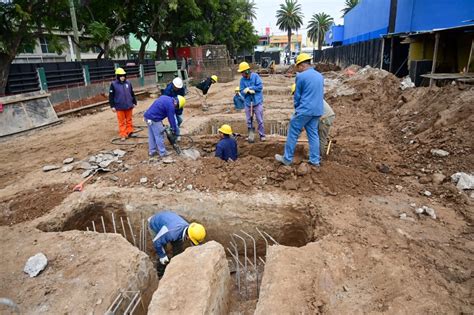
[284,114,320,165]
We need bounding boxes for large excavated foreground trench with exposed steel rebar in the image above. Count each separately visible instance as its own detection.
[38,194,321,310]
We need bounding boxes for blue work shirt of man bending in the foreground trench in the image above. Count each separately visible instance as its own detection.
[148,211,189,258]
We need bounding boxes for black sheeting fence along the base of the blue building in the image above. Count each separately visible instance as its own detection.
[314,39,383,68]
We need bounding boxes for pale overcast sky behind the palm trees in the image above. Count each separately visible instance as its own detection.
[253,0,344,40]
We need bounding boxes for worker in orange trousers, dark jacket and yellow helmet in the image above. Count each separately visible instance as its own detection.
[109,68,137,141]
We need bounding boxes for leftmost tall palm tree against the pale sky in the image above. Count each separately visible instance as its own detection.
[276,0,303,56]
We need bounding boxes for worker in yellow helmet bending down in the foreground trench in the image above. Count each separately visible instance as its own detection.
[148,211,206,279]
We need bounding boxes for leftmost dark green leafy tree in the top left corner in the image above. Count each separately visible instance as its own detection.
[0,0,71,94]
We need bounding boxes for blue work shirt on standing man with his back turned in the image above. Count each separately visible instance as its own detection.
[294,68,324,116]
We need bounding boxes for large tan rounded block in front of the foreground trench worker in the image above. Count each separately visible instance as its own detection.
[148,241,230,314]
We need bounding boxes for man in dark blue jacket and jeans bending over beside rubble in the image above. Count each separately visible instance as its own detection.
[143,95,186,158]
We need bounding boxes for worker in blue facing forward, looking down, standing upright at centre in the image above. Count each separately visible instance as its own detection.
[237,61,265,141]
